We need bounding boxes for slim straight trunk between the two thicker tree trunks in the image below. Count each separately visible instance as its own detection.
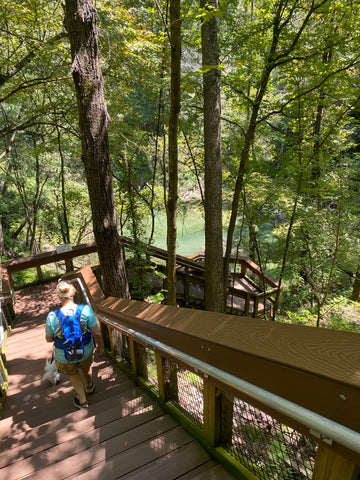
[166,0,181,305]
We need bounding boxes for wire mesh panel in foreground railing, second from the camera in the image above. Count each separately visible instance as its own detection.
[164,360,204,428]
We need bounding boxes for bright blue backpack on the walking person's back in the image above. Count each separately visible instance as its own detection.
[54,305,92,362]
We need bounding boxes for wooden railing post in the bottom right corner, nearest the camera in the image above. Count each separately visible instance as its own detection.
[312,445,360,480]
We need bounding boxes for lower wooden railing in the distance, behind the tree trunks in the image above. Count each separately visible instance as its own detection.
[4,236,278,317]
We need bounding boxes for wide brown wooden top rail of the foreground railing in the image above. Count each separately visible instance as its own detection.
[72,267,360,480]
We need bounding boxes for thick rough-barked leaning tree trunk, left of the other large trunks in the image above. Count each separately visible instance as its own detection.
[65,0,130,298]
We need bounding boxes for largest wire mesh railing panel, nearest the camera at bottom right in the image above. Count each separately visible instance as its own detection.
[221,398,317,480]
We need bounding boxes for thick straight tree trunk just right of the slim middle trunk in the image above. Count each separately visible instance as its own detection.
[200,0,225,312]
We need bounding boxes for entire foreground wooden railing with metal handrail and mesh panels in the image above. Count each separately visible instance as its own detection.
[67,267,360,480]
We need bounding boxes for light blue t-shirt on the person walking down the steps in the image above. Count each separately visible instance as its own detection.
[45,305,98,363]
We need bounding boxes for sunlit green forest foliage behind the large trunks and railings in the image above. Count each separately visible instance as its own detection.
[0,0,360,329]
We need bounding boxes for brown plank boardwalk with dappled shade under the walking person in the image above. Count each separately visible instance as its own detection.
[0,284,233,480]
